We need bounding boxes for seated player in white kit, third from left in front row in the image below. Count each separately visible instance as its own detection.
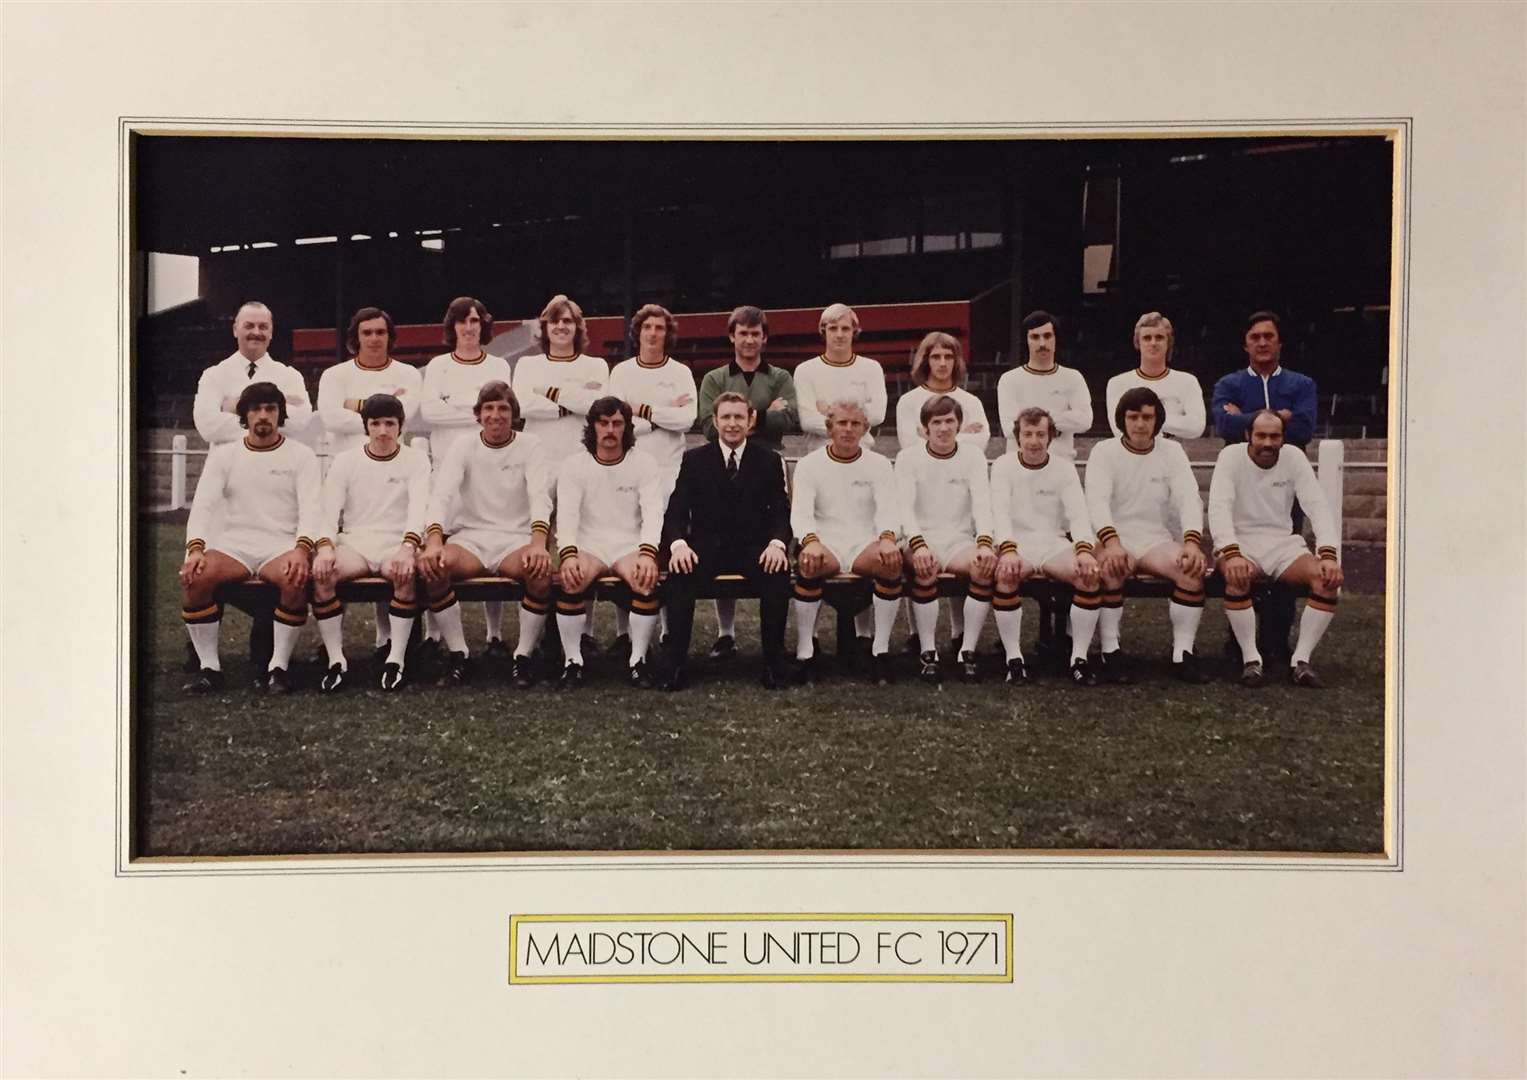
[417,380,551,689]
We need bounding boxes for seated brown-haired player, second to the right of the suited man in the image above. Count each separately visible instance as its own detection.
[896,394,997,683]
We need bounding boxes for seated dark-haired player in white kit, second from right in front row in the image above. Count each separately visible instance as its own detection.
[1087,386,1209,683]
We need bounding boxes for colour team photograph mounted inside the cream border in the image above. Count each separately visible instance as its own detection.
[121,118,1408,869]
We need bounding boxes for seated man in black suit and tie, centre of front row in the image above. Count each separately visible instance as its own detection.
[661,391,789,690]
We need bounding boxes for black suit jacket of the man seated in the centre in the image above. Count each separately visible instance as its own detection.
[663,438,789,562]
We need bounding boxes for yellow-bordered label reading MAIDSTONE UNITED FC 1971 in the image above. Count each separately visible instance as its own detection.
[508,912,1012,985]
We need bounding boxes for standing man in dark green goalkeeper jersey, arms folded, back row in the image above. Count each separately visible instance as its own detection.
[699,304,800,660]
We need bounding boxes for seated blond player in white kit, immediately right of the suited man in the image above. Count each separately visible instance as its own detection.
[789,402,901,683]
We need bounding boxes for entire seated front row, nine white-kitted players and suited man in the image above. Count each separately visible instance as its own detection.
[180,371,1341,692]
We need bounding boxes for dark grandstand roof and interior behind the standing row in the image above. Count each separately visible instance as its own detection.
[131,134,1394,426]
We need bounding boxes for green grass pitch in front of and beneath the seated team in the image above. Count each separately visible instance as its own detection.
[134,524,1383,855]
